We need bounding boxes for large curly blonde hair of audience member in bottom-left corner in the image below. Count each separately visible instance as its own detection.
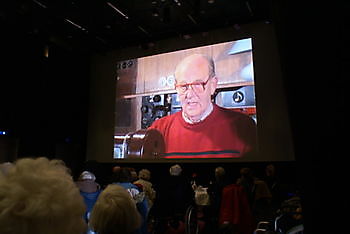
[0,157,86,234]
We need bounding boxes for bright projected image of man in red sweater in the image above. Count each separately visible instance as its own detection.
[113,38,258,160]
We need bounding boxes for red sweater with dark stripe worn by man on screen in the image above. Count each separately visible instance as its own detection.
[150,104,256,158]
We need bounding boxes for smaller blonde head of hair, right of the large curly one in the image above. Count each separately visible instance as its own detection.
[89,184,141,234]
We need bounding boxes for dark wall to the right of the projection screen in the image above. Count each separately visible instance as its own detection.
[274,1,350,233]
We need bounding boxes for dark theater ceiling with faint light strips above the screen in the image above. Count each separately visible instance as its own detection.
[0,0,271,53]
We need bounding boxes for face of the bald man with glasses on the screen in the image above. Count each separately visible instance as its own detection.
[175,57,216,120]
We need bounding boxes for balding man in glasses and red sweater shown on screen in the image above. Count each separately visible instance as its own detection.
[149,54,256,158]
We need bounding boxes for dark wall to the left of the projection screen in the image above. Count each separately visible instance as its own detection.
[0,22,89,176]
